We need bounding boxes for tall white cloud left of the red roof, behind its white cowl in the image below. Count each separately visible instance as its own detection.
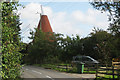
[18,3,52,42]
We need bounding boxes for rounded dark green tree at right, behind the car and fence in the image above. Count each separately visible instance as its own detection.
[88,29,118,63]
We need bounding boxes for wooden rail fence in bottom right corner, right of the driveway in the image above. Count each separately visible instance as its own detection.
[96,64,120,80]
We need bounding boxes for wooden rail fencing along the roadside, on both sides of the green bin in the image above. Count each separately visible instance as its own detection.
[57,63,120,80]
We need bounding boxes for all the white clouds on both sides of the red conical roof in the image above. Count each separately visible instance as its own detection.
[19,3,108,42]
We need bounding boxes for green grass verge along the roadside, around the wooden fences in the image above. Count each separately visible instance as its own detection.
[31,64,118,80]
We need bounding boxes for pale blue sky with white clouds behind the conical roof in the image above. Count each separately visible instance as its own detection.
[18,0,108,43]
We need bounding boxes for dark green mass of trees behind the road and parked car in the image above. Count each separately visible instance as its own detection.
[28,28,119,64]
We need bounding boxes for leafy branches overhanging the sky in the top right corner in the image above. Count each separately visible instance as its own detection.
[91,0,120,34]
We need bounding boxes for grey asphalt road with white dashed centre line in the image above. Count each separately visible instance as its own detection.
[21,66,95,80]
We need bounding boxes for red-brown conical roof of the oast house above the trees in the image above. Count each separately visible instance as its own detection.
[37,15,53,32]
